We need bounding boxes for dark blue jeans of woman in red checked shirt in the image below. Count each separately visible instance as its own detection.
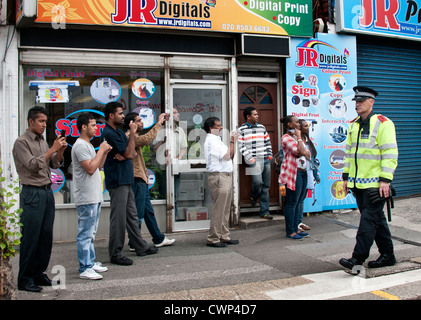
[284,170,307,235]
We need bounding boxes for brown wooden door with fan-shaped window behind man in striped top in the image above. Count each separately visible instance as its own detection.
[238,82,279,211]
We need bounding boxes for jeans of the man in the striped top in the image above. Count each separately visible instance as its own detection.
[246,159,270,217]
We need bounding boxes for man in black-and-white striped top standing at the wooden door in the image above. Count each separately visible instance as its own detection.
[238,107,273,220]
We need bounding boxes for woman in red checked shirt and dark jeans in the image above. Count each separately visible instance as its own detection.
[279,115,311,240]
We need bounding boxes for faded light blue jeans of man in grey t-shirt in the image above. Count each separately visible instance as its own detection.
[76,203,101,273]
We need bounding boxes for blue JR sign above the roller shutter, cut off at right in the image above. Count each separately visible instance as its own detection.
[336,0,421,40]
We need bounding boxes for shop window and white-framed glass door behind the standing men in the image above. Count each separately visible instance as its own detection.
[20,48,231,238]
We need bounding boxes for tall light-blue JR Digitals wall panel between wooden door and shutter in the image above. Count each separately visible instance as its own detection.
[286,33,357,212]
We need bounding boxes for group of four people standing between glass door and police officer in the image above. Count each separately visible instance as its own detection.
[204,107,320,247]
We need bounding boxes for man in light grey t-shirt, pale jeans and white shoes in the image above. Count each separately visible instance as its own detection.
[72,112,112,280]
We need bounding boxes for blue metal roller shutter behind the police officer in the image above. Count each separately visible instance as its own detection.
[357,38,421,197]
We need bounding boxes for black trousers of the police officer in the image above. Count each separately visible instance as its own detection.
[352,189,393,261]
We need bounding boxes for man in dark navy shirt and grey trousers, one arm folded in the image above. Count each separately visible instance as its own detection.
[101,102,158,265]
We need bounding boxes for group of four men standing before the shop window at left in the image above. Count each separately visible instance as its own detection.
[13,102,175,292]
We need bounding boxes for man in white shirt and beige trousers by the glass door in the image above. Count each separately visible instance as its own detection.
[204,117,239,248]
